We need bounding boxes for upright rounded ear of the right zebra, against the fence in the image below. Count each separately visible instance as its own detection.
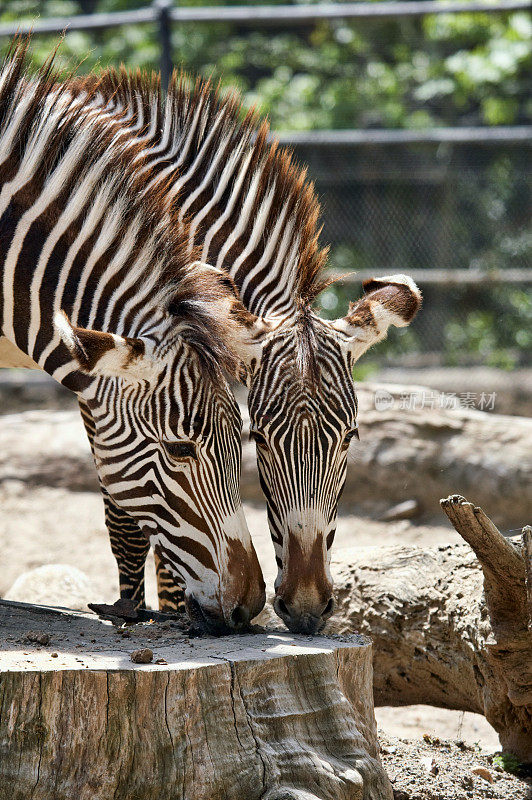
[332,275,421,361]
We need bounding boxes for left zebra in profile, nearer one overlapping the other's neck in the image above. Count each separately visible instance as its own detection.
[0,41,265,632]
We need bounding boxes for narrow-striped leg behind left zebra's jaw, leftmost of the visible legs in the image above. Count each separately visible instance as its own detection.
[79,400,150,608]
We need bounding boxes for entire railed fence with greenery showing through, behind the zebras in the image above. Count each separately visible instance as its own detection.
[0,0,532,369]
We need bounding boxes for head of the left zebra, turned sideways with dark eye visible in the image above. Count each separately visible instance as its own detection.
[54,272,265,633]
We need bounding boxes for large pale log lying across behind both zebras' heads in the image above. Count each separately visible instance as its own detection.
[0,384,532,527]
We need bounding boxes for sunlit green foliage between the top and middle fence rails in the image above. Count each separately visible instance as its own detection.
[0,0,532,130]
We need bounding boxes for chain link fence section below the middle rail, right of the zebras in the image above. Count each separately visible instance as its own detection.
[294,141,532,368]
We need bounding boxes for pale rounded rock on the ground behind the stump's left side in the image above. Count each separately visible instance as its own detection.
[4,564,94,611]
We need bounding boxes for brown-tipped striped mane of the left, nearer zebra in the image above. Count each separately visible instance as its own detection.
[0,42,241,375]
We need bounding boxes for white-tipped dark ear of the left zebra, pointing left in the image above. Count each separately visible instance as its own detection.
[54,311,156,380]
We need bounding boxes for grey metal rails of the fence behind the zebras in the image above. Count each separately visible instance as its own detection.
[0,0,532,286]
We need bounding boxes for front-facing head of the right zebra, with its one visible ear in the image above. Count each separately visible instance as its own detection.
[233,275,421,633]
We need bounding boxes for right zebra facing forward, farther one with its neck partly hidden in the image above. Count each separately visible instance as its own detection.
[71,65,421,633]
